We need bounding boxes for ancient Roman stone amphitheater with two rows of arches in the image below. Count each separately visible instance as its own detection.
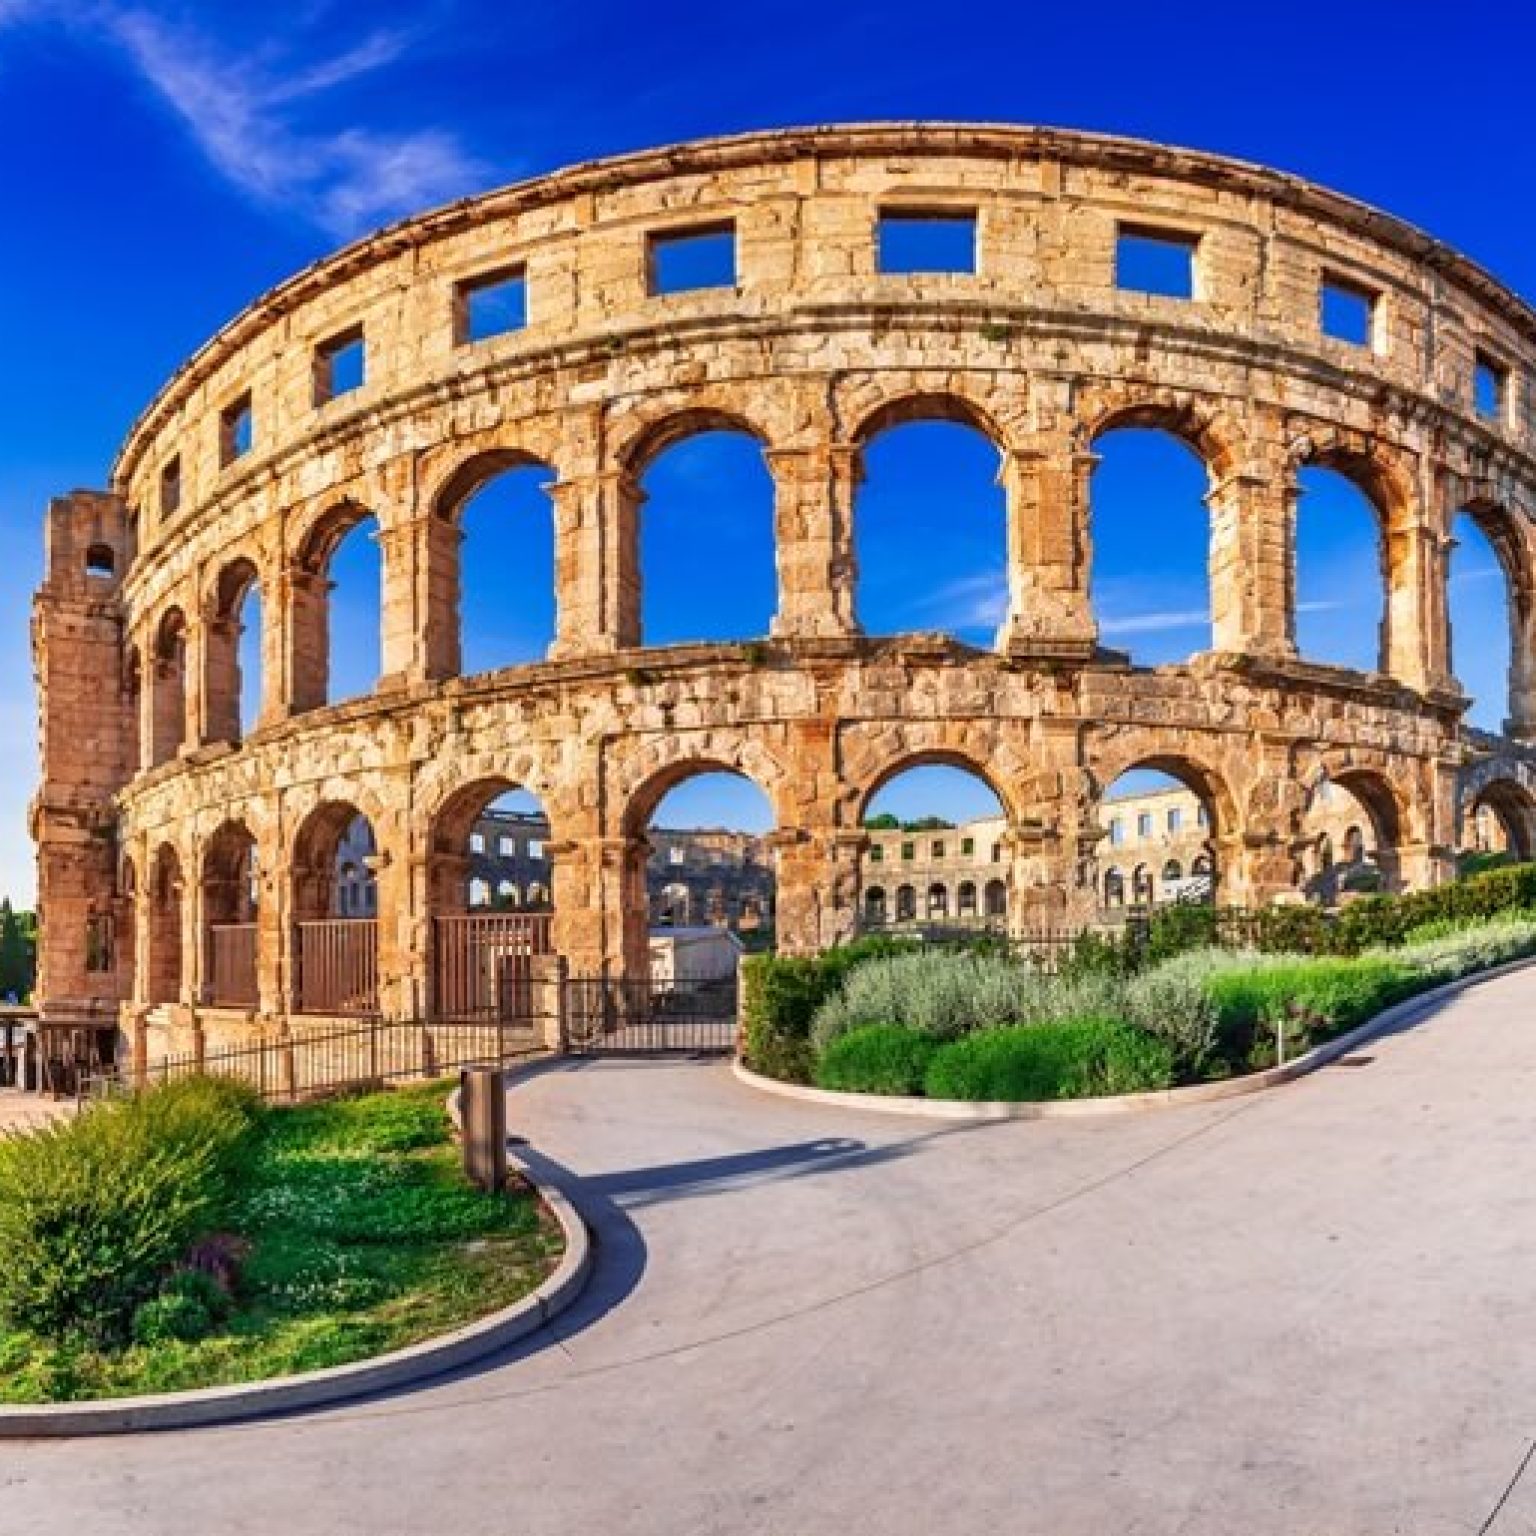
[34,124,1536,1052]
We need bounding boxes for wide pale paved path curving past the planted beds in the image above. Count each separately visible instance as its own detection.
[9,969,1536,1536]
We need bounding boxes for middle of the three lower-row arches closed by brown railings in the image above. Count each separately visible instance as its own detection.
[293,800,379,1017]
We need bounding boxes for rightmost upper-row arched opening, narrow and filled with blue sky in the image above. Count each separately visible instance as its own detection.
[1445,510,1531,733]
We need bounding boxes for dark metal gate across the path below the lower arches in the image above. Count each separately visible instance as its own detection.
[564,975,737,1054]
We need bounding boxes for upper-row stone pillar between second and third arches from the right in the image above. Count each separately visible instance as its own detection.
[1206,470,1296,657]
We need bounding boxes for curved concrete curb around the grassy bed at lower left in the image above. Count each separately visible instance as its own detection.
[0,1075,593,1439]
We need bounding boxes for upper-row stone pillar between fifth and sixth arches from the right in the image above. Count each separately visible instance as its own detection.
[550,470,645,657]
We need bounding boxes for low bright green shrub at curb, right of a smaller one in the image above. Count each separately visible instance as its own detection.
[923,1018,1174,1103]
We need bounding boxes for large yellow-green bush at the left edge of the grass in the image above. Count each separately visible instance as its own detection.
[0,1081,255,1339]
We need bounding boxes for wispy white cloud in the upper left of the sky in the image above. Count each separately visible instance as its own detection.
[0,0,487,238]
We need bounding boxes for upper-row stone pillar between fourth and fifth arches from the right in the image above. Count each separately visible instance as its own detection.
[763,442,863,639]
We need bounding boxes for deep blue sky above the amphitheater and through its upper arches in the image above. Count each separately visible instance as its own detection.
[0,0,1536,899]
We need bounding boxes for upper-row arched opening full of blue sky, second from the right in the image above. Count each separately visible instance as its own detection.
[1295,464,1387,671]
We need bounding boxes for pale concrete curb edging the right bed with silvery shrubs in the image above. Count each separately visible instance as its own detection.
[731,955,1536,1120]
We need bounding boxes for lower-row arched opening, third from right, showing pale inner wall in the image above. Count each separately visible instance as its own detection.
[1098,759,1218,911]
